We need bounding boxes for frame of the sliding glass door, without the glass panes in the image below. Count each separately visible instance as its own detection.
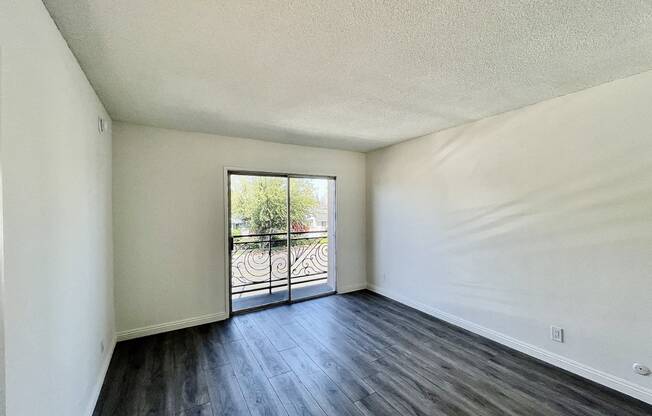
[224,167,338,316]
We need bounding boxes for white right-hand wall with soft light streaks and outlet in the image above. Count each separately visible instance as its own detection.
[367,68,652,402]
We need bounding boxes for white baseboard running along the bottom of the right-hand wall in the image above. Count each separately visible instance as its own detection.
[367,284,652,404]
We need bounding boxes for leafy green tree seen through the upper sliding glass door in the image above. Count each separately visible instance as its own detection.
[231,177,319,234]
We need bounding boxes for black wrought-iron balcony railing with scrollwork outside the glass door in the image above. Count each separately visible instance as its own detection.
[231,231,328,295]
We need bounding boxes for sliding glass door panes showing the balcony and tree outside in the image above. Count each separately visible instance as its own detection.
[228,172,336,312]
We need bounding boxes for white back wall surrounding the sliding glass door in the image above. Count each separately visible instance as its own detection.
[113,123,366,338]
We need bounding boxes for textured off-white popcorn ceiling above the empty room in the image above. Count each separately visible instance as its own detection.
[45,0,652,151]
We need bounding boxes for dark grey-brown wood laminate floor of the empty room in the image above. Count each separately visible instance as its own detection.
[94,291,652,416]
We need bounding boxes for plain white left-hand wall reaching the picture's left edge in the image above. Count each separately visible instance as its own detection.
[0,0,114,416]
